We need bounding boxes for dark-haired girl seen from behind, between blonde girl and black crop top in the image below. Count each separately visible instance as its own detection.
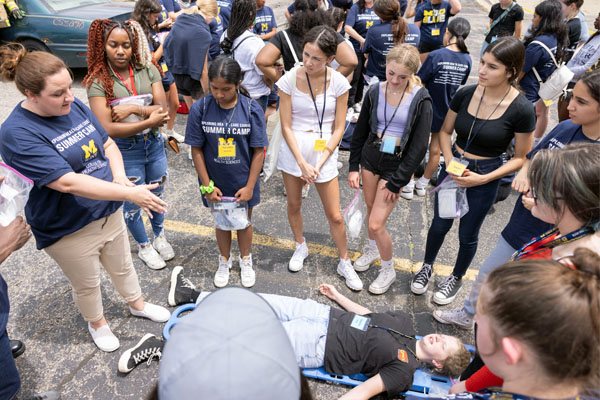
[412,17,471,200]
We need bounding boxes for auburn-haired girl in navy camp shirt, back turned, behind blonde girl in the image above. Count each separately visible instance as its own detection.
[363,0,421,81]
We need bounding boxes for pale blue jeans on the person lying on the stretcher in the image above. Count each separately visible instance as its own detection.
[196,292,331,368]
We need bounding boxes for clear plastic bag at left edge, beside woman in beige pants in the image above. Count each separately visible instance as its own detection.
[0,163,33,226]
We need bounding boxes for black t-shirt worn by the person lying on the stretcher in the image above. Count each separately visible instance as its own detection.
[325,307,419,396]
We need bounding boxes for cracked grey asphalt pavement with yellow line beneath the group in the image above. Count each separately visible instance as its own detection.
[0,0,556,400]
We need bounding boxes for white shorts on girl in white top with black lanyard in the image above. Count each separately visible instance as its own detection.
[277,131,338,183]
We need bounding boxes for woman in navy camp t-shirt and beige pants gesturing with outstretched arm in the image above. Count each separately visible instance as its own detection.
[0,45,170,354]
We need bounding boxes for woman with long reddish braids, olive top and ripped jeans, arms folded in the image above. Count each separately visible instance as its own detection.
[83,19,175,269]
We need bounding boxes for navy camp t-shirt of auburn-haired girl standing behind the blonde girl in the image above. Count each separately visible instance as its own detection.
[363,22,421,81]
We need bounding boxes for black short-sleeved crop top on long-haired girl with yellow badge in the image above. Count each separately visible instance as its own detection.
[450,85,536,157]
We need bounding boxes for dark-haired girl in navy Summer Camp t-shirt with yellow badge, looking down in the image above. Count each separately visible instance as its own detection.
[185,56,268,287]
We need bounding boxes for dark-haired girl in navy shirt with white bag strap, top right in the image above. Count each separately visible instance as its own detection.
[519,0,569,145]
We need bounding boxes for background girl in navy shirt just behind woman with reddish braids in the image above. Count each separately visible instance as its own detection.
[131,0,184,143]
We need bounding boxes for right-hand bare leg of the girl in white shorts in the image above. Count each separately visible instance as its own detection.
[315,177,348,260]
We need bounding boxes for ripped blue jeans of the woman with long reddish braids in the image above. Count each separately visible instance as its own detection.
[115,133,168,244]
